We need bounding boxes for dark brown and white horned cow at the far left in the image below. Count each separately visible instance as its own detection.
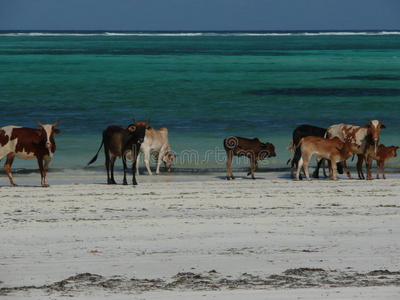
[0,119,60,187]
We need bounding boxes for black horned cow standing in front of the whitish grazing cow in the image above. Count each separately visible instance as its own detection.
[87,119,150,185]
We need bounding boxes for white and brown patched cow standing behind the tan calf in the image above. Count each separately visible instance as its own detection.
[327,120,386,180]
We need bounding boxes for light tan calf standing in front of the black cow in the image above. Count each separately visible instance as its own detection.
[296,136,353,180]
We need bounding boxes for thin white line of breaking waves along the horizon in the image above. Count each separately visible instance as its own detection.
[0,31,400,37]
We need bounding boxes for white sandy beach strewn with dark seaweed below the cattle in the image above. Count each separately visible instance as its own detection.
[0,172,400,299]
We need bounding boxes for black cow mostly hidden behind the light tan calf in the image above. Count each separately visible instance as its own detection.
[287,125,343,179]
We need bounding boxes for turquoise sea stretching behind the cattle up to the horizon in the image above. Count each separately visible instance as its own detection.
[0,31,400,172]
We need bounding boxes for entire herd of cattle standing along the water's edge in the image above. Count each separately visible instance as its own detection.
[0,120,399,187]
